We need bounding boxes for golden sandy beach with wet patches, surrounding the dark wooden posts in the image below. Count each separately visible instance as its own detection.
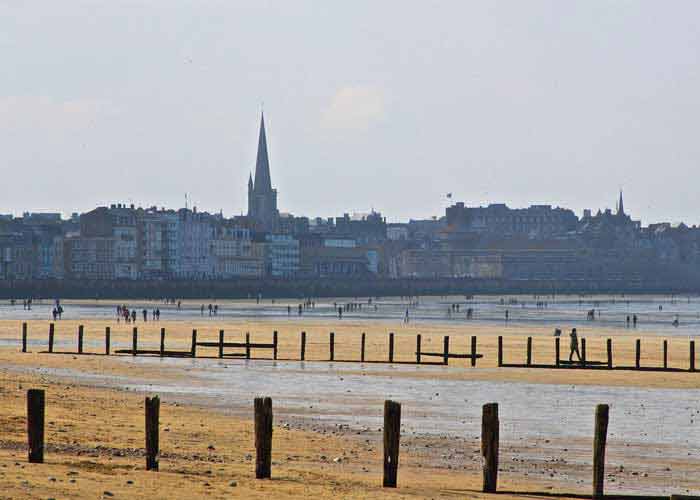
[0,298,700,498]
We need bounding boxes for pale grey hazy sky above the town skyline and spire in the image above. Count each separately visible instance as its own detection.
[0,0,700,224]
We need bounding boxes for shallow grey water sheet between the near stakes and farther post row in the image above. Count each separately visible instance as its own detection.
[26,357,700,456]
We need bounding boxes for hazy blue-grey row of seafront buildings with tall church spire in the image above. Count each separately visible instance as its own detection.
[0,114,700,280]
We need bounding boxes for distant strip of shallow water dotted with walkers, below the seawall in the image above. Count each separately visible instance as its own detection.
[0,296,700,337]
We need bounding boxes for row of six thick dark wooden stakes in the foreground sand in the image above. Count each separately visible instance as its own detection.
[21,389,609,498]
